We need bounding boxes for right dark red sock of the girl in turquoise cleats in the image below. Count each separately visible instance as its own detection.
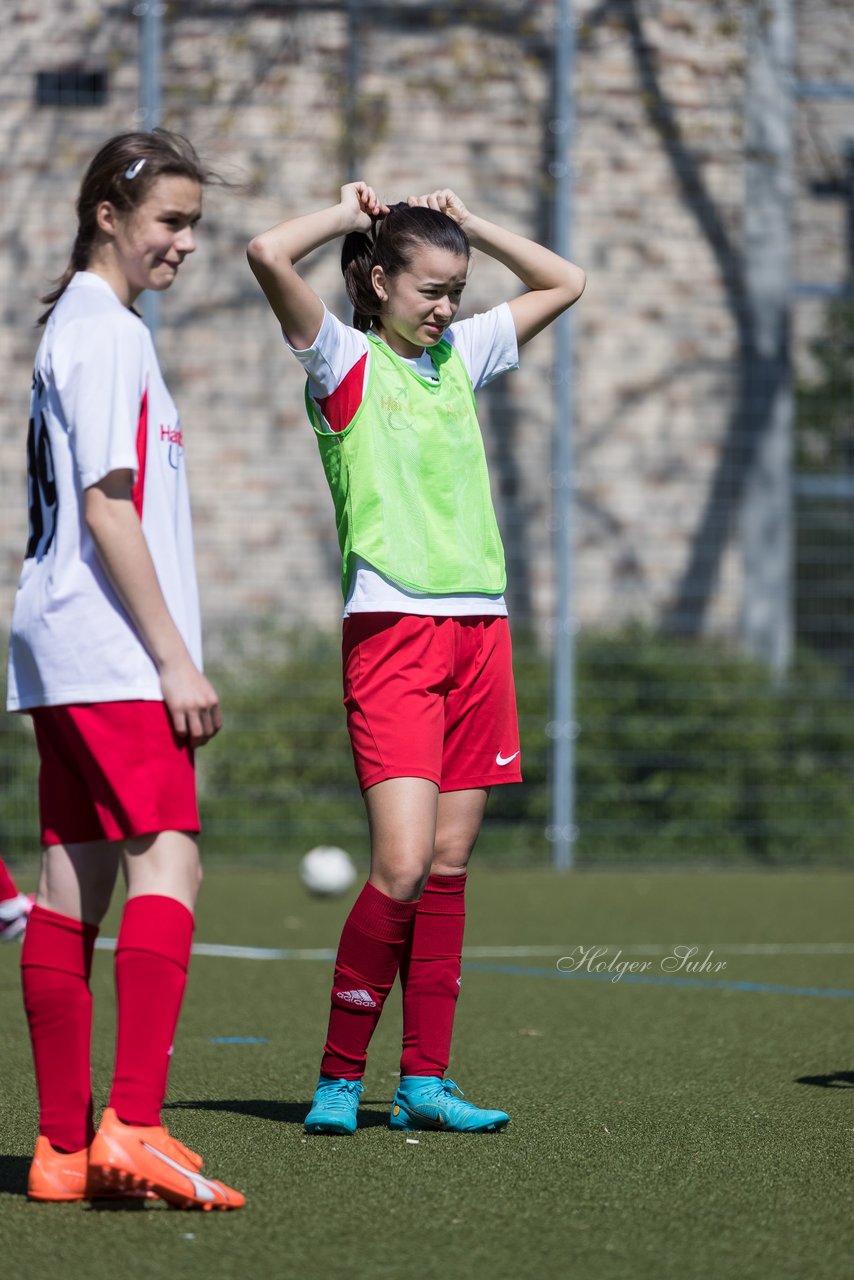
[401,876,466,1075]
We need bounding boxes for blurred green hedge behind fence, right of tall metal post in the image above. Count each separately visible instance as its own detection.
[577,631,854,865]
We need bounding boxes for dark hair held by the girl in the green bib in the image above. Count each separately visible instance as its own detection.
[341,204,471,333]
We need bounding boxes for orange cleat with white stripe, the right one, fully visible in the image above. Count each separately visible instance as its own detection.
[87,1107,246,1210]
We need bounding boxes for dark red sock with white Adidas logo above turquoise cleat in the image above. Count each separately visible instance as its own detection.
[320,882,417,1080]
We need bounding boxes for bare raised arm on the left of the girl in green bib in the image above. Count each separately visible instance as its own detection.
[246,182,387,351]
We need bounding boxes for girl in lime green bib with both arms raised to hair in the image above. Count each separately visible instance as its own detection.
[248,182,584,1133]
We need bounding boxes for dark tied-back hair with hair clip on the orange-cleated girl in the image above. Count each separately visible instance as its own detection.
[38,129,214,324]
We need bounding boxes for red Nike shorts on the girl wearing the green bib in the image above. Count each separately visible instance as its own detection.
[343,613,522,791]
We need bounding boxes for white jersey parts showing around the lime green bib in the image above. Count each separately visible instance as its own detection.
[286,302,519,617]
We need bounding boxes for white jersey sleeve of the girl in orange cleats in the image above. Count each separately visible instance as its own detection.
[52,315,146,489]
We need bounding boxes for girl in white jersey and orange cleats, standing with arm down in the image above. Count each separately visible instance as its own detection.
[8,129,243,1208]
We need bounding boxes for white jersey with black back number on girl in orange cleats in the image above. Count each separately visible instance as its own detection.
[6,271,201,710]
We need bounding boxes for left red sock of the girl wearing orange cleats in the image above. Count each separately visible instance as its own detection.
[20,906,97,1151]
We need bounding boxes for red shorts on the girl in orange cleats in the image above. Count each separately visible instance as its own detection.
[31,701,200,845]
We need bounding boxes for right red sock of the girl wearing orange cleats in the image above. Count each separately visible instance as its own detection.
[110,893,193,1125]
